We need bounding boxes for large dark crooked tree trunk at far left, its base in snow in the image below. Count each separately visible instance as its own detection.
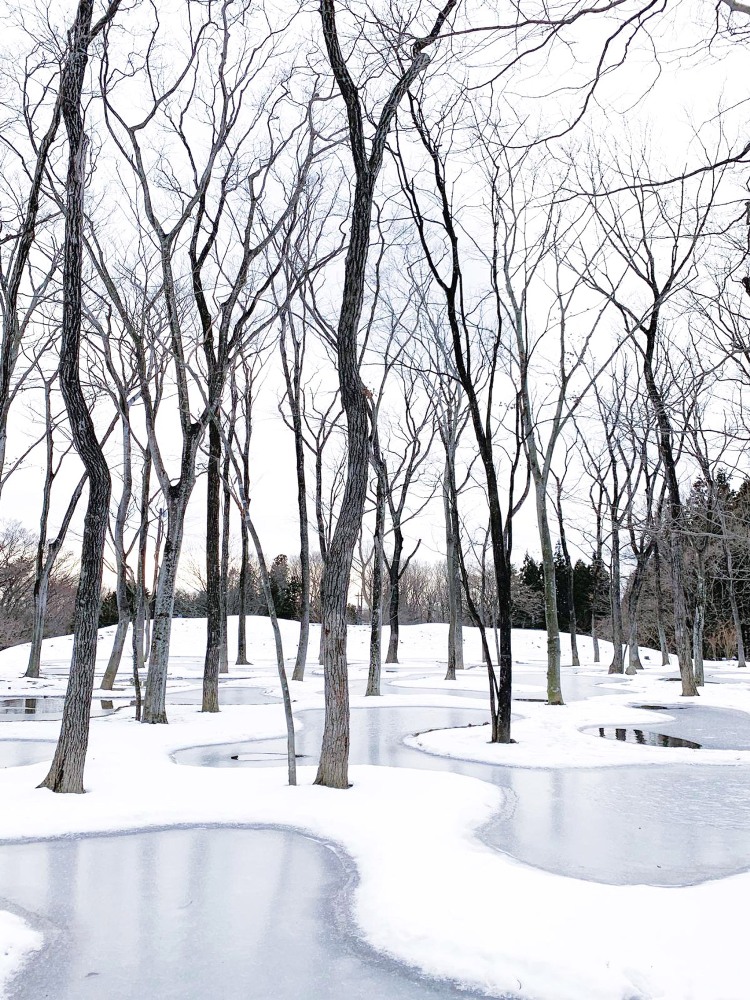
[42,0,117,792]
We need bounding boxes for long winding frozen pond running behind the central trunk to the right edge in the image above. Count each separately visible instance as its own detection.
[174,707,750,885]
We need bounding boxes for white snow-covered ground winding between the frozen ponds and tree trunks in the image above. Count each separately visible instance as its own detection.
[0,619,750,1000]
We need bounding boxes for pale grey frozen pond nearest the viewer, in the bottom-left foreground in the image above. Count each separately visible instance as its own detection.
[0,828,506,1000]
